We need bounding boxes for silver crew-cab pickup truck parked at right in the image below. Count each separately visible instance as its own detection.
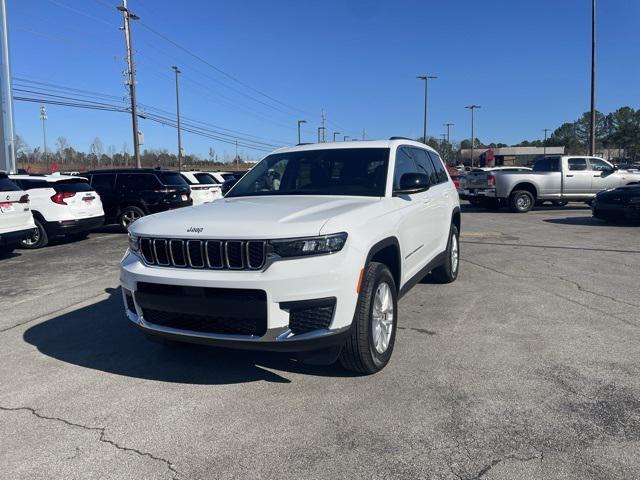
[467,155,640,213]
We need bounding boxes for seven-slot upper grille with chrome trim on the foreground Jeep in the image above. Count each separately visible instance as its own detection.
[140,237,267,271]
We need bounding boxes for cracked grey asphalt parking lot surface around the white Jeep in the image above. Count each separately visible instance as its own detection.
[0,206,640,480]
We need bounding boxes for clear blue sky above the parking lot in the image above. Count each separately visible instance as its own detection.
[8,0,640,161]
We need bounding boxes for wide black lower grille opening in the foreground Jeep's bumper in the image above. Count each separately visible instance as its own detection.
[136,282,267,337]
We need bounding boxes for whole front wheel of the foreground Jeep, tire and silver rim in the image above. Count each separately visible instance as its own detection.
[339,262,398,375]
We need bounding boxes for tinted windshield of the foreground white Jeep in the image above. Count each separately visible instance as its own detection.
[227,148,389,198]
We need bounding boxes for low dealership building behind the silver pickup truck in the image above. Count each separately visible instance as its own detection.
[460,147,565,167]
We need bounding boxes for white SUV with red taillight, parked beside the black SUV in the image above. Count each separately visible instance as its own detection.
[10,174,104,248]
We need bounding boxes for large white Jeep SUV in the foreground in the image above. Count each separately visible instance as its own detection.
[120,138,460,373]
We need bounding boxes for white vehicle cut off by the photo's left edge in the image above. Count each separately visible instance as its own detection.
[0,172,36,257]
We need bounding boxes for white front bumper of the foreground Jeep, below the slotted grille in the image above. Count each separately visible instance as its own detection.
[120,246,365,352]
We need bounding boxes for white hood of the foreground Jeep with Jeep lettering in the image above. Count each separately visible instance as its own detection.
[130,195,380,240]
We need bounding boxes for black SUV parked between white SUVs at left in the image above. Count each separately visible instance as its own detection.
[80,168,193,229]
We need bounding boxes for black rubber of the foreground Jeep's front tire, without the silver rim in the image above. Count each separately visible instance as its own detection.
[339,262,398,375]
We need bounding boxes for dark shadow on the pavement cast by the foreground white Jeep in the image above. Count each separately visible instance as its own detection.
[24,289,352,385]
